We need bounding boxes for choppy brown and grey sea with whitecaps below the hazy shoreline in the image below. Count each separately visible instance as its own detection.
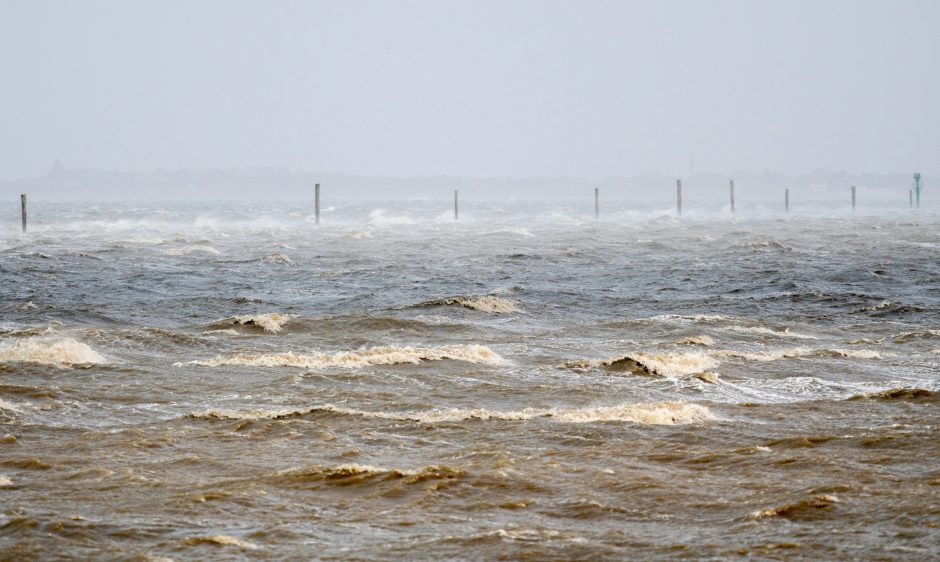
[0,201,940,560]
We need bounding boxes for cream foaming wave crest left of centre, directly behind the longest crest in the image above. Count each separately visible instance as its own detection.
[185,345,505,369]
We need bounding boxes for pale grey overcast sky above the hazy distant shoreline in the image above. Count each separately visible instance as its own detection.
[0,0,940,179]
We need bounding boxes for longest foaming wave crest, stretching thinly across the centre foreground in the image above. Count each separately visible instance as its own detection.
[190,402,717,425]
